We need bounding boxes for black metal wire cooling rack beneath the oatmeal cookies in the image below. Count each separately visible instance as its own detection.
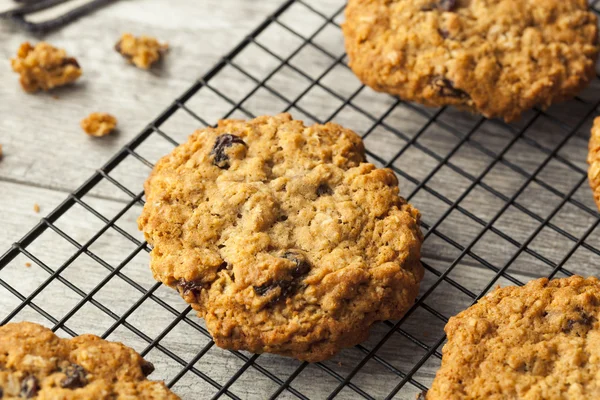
[0,0,600,399]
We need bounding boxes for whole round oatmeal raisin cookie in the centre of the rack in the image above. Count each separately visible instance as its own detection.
[139,114,423,361]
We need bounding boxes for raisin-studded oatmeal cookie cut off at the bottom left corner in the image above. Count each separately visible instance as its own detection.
[0,322,179,400]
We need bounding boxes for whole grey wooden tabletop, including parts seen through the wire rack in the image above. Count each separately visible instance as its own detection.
[0,0,600,399]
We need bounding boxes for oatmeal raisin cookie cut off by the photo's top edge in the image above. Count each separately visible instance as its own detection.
[343,0,598,121]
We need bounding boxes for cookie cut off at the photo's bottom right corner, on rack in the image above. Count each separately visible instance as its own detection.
[427,276,600,400]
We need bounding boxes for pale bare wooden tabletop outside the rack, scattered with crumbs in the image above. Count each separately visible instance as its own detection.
[0,0,281,249]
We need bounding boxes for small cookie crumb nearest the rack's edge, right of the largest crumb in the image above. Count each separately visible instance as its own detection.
[115,33,169,69]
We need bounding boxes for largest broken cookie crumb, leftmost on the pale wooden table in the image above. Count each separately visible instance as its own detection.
[11,42,81,93]
